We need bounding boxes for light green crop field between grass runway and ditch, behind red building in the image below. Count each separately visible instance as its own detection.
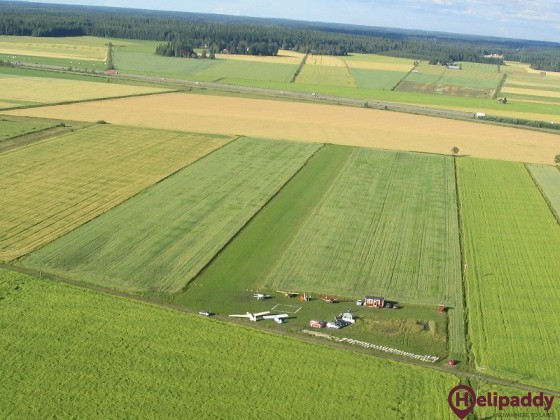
[263,149,460,304]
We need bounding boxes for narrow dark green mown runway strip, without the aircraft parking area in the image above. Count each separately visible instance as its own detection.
[175,145,353,308]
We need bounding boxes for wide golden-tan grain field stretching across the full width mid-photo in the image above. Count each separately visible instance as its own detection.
[6,93,560,164]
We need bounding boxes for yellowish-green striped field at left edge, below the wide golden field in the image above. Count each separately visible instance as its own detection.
[0,125,229,261]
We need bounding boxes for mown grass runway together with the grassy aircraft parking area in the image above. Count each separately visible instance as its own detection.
[174,145,452,360]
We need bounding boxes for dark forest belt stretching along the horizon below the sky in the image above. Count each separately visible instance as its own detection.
[0,2,560,71]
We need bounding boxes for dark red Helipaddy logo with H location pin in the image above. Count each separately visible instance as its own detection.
[447,385,554,420]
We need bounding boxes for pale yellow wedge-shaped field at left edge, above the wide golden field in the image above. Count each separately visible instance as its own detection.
[0,74,166,107]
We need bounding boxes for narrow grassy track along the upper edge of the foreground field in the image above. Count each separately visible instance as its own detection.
[0,263,560,397]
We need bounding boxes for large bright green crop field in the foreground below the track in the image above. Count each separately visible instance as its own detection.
[0,271,458,419]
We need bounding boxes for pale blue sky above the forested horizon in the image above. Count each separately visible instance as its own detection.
[7,0,560,42]
